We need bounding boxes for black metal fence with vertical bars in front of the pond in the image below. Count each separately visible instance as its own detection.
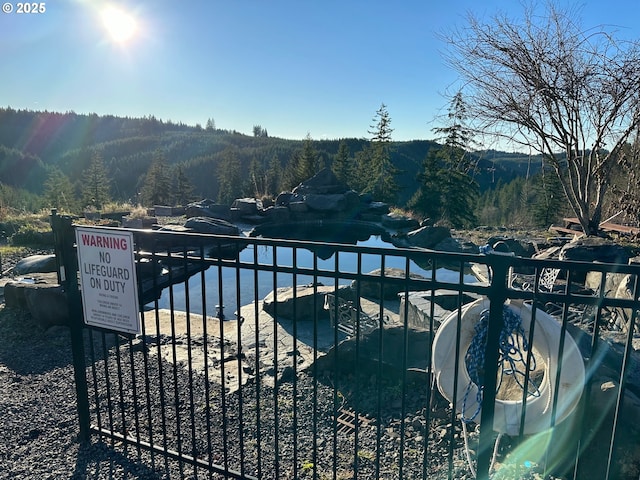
[52,215,640,479]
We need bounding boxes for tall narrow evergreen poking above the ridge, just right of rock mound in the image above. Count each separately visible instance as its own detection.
[362,103,400,203]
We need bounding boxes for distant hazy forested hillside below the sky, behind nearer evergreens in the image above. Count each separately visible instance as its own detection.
[0,108,540,205]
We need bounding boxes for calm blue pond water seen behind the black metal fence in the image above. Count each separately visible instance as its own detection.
[158,236,475,318]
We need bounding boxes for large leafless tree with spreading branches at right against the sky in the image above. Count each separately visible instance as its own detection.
[445,4,640,234]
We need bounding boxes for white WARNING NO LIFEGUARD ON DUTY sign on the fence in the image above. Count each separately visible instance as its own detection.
[76,227,141,334]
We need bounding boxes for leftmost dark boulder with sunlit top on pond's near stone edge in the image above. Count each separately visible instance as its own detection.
[262,285,334,321]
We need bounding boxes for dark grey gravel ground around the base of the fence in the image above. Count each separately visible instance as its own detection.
[0,248,576,480]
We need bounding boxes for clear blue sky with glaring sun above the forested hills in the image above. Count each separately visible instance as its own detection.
[0,0,640,140]
